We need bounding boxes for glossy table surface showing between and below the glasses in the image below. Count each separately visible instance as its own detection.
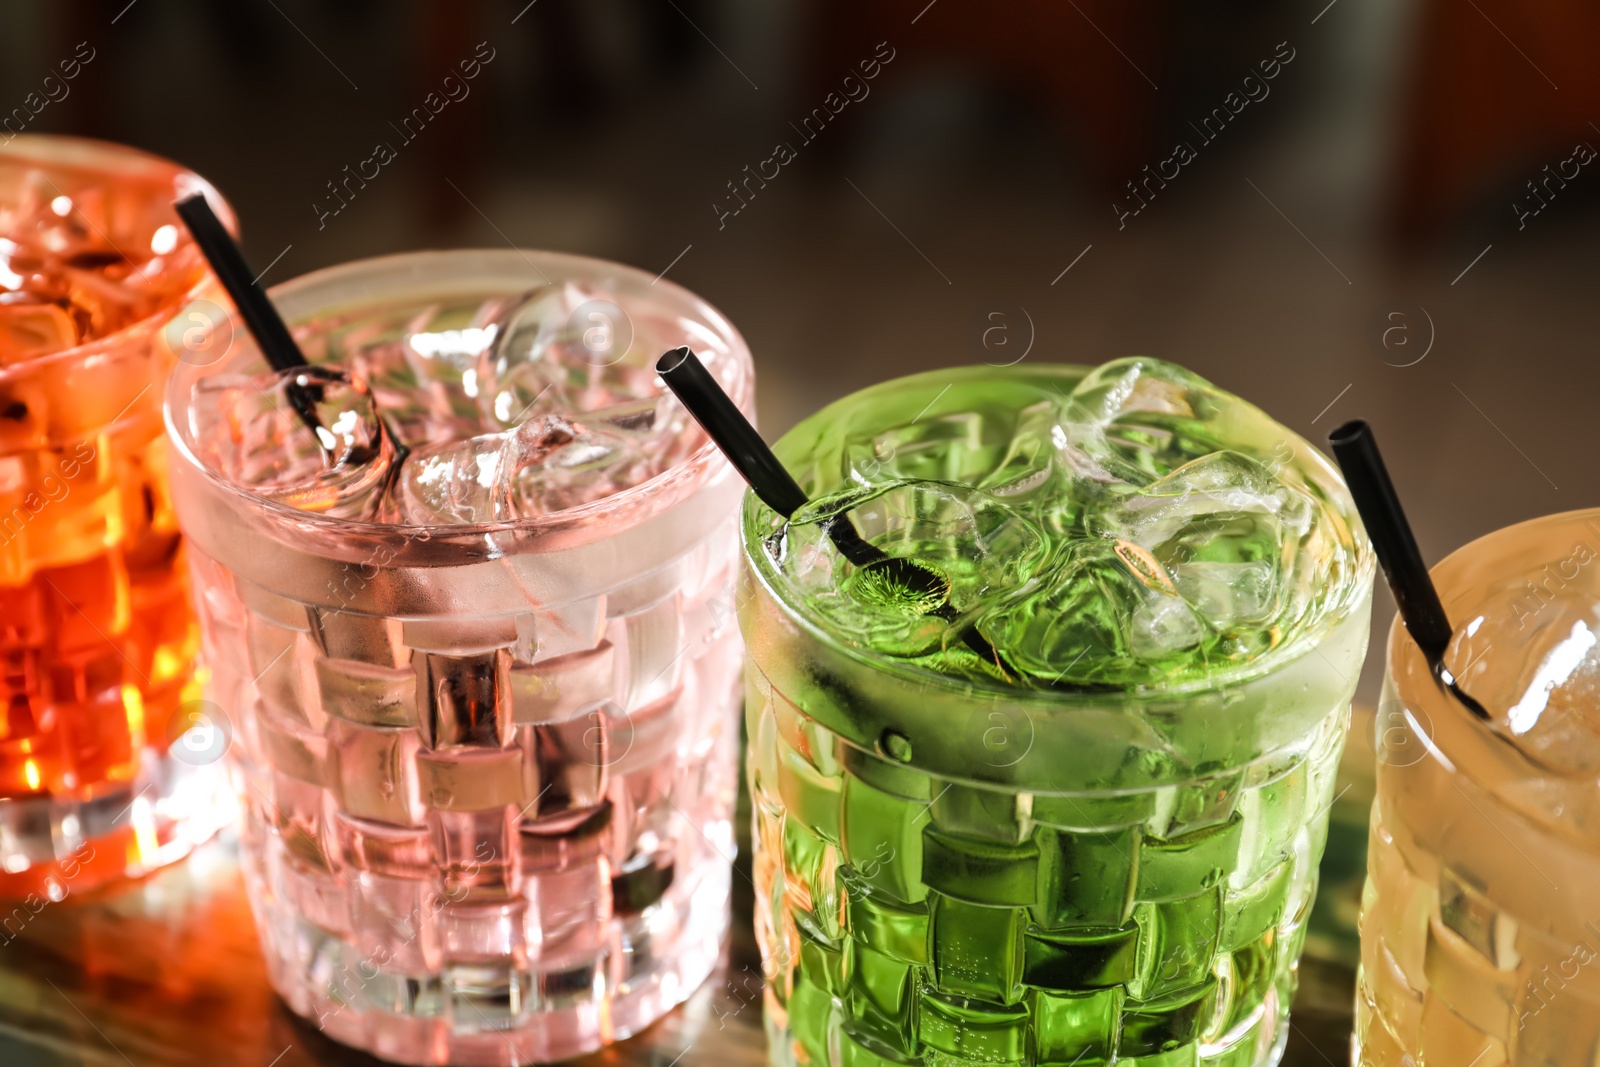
[0,835,1354,1067]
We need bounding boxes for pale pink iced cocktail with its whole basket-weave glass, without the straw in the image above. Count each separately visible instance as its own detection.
[168,251,754,1064]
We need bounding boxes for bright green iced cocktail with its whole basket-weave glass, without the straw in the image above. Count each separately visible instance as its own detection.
[739,360,1373,1067]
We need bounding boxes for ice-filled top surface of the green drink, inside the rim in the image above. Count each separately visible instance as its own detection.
[765,360,1354,689]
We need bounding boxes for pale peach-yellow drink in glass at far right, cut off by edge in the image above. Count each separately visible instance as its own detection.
[1355,510,1600,1067]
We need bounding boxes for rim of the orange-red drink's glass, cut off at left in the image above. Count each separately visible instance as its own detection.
[0,133,238,382]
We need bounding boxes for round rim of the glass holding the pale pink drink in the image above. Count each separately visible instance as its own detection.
[162,248,755,544]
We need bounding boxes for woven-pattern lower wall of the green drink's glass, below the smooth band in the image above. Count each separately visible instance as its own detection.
[746,665,1346,1067]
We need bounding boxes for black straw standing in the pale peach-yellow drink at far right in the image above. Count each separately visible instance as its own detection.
[1328,419,1490,718]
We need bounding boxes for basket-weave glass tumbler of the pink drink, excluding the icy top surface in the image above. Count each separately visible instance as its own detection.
[168,251,754,1064]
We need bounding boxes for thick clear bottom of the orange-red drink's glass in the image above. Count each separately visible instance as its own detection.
[0,750,237,902]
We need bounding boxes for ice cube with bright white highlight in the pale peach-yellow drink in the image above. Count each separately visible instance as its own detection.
[1445,585,1600,777]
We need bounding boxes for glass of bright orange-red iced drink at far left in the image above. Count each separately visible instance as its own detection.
[0,134,232,902]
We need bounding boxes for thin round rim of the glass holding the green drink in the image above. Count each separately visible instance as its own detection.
[739,362,1378,709]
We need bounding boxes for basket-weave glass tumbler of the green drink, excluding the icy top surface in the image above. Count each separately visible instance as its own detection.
[739,368,1371,1067]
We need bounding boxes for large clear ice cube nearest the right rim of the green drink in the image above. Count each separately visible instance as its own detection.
[1088,451,1315,629]
